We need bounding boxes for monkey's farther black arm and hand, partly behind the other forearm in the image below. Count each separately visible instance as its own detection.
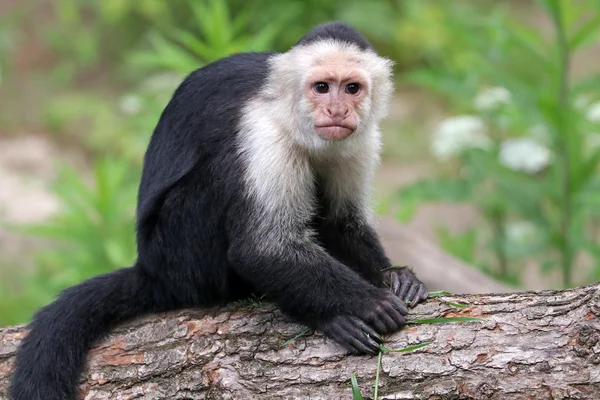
[319,215,428,307]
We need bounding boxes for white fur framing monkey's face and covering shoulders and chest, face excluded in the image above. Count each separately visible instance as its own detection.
[237,41,393,250]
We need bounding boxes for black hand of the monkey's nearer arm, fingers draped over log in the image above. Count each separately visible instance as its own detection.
[317,289,408,354]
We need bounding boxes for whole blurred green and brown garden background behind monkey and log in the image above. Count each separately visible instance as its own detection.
[0,0,600,326]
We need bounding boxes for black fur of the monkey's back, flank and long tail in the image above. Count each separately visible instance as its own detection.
[9,53,270,400]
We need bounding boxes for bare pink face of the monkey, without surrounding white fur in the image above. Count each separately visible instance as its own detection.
[304,56,369,141]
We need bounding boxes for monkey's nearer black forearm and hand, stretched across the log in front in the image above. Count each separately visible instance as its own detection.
[228,225,408,354]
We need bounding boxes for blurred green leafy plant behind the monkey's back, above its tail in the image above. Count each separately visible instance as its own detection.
[0,157,140,323]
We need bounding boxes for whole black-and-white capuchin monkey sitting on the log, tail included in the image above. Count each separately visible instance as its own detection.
[10,22,427,400]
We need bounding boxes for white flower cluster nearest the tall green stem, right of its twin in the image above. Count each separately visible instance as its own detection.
[499,137,552,173]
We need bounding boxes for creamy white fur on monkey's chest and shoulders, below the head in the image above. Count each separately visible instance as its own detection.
[238,99,381,231]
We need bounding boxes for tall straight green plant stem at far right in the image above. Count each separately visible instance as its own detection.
[552,2,573,287]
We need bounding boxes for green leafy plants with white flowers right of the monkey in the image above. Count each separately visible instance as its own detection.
[397,0,600,286]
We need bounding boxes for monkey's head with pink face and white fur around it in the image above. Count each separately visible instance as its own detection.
[271,26,393,148]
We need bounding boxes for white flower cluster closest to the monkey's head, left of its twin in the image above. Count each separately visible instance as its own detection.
[431,115,492,160]
